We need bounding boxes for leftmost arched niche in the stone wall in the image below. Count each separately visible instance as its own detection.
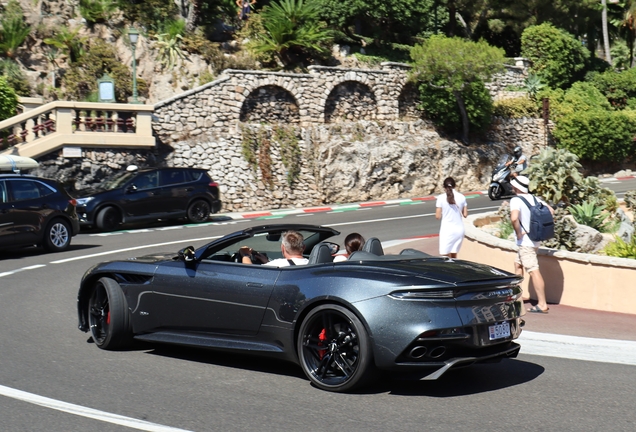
[239,85,300,123]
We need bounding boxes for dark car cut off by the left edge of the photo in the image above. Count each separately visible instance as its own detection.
[0,174,79,252]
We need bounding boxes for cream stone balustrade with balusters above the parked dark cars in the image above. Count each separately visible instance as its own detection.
[0,101,155,157]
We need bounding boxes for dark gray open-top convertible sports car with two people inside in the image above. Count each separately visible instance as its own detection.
[77,225,522,392]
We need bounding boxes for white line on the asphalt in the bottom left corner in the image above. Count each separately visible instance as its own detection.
[0,385,190,432]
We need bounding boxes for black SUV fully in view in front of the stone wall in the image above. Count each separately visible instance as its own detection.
[76,168,222,231]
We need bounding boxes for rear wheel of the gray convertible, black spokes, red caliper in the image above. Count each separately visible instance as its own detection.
[298,305,375,392]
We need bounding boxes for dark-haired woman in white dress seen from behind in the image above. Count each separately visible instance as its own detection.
[435,177,468,258]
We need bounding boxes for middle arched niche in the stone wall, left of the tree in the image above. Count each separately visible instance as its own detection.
[325,81,378,123]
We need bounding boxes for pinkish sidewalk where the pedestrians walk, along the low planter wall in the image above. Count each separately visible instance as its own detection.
[384,236,636,341]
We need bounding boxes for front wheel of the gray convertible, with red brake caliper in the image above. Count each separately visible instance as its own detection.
[88,277,132,350]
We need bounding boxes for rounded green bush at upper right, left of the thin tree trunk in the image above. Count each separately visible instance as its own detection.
[521,23,589,88]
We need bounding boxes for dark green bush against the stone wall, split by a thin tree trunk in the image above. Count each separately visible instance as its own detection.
[419,81,493,131]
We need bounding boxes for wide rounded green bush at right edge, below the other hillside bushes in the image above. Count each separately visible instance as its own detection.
[553,110,636,162]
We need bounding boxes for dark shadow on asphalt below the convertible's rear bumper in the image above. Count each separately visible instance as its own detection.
[378,359,545,398]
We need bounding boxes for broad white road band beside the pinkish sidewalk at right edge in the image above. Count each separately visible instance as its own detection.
[517,330,636,366]
